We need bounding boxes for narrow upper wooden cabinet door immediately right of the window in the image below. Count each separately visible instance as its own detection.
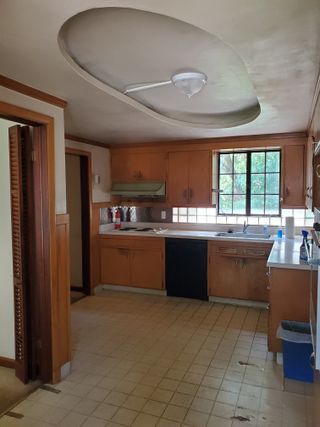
[282,144,306,208]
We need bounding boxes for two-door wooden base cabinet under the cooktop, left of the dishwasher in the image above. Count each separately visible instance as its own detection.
[100,236,164,289]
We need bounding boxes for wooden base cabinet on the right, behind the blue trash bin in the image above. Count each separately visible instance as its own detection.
[268,268,316,352]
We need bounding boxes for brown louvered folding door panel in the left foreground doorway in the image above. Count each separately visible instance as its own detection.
[9,126,31,383]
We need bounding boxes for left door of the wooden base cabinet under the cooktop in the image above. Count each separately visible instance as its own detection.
[100,247,130,285]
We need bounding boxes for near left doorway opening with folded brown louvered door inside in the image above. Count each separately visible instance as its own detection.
[0,117,51,412]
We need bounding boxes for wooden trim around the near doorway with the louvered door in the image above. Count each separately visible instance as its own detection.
[0,101,59,381]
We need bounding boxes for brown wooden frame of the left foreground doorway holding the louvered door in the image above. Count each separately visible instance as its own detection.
[0,101,59,382]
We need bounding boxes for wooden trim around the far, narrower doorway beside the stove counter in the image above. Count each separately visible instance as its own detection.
[65,147,94,295]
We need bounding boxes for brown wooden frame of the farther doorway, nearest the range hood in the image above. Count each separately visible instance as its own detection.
[65,147,93,295]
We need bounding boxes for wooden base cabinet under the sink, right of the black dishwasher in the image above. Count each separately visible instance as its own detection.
[208,242,272,302]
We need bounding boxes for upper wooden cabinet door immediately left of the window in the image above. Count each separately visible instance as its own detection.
[188,151,212,207]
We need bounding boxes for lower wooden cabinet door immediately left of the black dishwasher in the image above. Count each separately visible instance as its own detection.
[131,249,163,289]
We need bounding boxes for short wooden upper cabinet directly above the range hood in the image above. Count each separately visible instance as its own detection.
[111,151,166,182]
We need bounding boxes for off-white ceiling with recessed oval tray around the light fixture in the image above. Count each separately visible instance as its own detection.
[0,0,320,143]
